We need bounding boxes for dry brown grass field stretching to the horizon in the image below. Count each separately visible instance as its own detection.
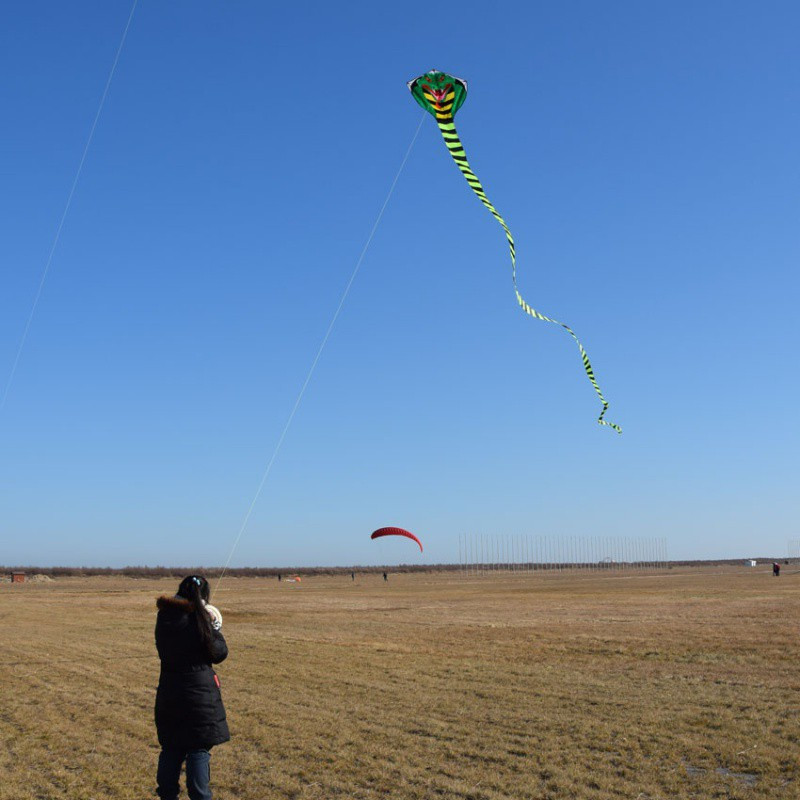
[0,568,800,800]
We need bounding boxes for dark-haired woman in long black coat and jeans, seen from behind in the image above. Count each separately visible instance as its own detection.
[156,575,231,800]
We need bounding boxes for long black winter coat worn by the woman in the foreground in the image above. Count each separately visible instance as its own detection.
[156,597,231,752]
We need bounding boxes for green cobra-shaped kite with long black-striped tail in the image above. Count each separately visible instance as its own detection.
[408,69,622,433]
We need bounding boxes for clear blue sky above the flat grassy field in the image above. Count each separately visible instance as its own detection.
[0,0,800,565]
